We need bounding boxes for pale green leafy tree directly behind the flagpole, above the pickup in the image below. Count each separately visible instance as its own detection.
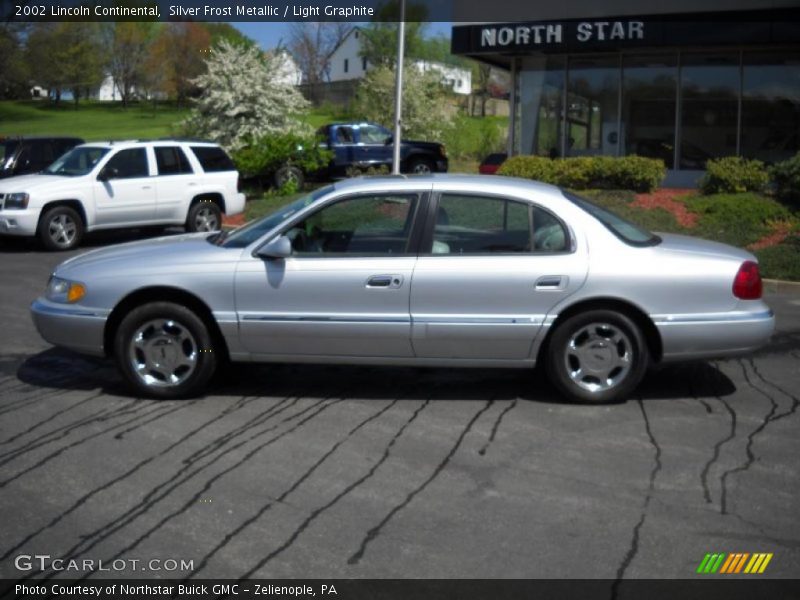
[354,61,452,140]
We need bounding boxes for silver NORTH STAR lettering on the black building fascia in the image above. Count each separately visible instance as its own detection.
[480,21,645,49]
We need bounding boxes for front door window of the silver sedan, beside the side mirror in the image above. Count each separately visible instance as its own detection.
[285,194,418,257]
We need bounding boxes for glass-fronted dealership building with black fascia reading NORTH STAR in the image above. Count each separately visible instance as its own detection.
[452,0,800,186]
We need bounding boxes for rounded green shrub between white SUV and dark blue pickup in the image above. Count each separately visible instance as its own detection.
[233,133,333,186]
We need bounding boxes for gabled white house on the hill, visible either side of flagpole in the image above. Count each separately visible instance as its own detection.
[328,27,472,94]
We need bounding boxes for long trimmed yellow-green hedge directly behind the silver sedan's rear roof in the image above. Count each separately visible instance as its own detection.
[498,156,666,192]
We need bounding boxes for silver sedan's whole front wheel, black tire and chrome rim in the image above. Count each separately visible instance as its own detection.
[114,302,220,399]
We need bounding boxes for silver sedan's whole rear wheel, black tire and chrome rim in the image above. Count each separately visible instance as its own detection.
[545,310,650,404]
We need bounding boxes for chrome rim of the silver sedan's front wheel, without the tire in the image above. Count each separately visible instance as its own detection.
[128,319,199,387]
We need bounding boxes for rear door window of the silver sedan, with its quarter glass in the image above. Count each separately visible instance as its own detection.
[431,194,569,255]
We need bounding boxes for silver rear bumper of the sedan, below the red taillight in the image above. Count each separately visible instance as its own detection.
[653,308,775,362]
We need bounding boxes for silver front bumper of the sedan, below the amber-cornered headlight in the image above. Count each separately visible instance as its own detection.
[31,298,110,356]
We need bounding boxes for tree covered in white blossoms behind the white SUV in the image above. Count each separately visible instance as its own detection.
[183,39,308,151]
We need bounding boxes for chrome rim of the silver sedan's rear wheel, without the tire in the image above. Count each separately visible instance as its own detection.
[564,323,633,393]
